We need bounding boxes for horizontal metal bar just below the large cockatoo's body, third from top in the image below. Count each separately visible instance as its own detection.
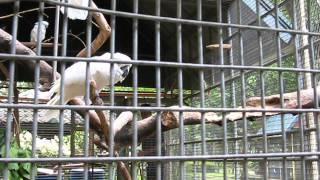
[0,103,320,114]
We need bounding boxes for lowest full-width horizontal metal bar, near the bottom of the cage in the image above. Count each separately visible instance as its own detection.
[0,152,320,163]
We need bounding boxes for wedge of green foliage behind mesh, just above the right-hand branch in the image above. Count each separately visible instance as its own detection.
[189,55,298,111]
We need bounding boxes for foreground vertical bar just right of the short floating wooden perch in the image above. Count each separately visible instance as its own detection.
[237,0,248,179]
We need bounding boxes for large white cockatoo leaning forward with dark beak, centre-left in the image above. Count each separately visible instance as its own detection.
[44,53,131,120]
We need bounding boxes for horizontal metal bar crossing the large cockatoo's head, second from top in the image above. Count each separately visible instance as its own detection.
[0,53,320,73]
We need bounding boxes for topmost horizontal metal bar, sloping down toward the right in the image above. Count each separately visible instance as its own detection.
[18,0,320,36]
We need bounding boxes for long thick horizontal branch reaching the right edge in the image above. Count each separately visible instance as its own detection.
[115,87,320,147]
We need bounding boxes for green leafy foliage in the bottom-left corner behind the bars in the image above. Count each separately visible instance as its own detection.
[0,131,32,180]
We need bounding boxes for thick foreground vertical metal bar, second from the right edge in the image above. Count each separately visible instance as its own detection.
[292,0,307,179]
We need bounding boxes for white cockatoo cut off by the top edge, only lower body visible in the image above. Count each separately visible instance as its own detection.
[60,0,89,20]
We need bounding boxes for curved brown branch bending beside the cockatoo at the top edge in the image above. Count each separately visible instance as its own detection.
[77,2,111,57]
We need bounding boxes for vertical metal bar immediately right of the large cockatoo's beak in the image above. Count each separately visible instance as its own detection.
[131,0,139,180]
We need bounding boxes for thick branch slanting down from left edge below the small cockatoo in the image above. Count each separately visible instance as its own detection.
[0,29,60,89]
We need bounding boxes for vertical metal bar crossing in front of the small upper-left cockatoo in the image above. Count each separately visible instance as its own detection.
[31,2,44,179]
